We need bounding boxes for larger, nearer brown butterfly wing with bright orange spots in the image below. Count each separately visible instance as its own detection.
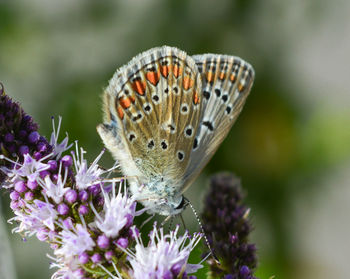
[98,46,202,187]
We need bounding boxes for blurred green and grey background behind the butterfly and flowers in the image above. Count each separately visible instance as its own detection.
[0,0,350,279]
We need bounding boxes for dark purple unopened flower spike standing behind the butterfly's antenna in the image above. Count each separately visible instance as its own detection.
[202,174,257,279]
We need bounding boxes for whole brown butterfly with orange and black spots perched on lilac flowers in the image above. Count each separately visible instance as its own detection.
[97,46,254,216]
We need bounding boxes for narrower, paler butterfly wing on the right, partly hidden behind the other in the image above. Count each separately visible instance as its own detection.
[182,54,254,191]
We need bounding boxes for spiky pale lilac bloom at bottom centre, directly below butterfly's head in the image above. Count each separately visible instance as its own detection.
[127,224,202,279]
